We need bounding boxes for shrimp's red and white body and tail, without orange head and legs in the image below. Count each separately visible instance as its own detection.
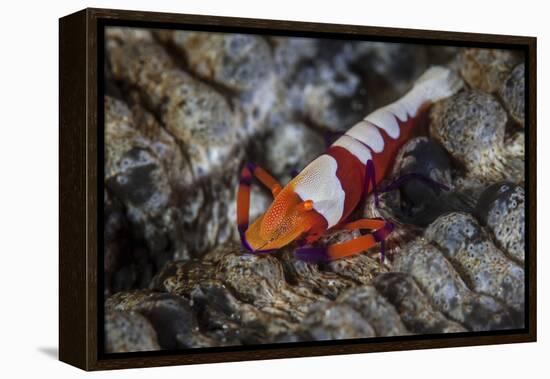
[290,66,462,229]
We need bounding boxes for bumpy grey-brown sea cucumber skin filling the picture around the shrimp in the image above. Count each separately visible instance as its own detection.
[103,28,525,352]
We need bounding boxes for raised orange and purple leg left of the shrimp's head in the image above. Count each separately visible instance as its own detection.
[237,163,282,250]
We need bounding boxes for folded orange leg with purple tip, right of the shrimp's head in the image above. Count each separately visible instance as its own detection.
[294,219,394,262]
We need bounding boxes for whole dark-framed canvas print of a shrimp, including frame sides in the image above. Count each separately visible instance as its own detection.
[59,9,536,370]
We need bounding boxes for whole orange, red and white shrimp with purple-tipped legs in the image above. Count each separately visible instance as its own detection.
[237,66,462,262]
